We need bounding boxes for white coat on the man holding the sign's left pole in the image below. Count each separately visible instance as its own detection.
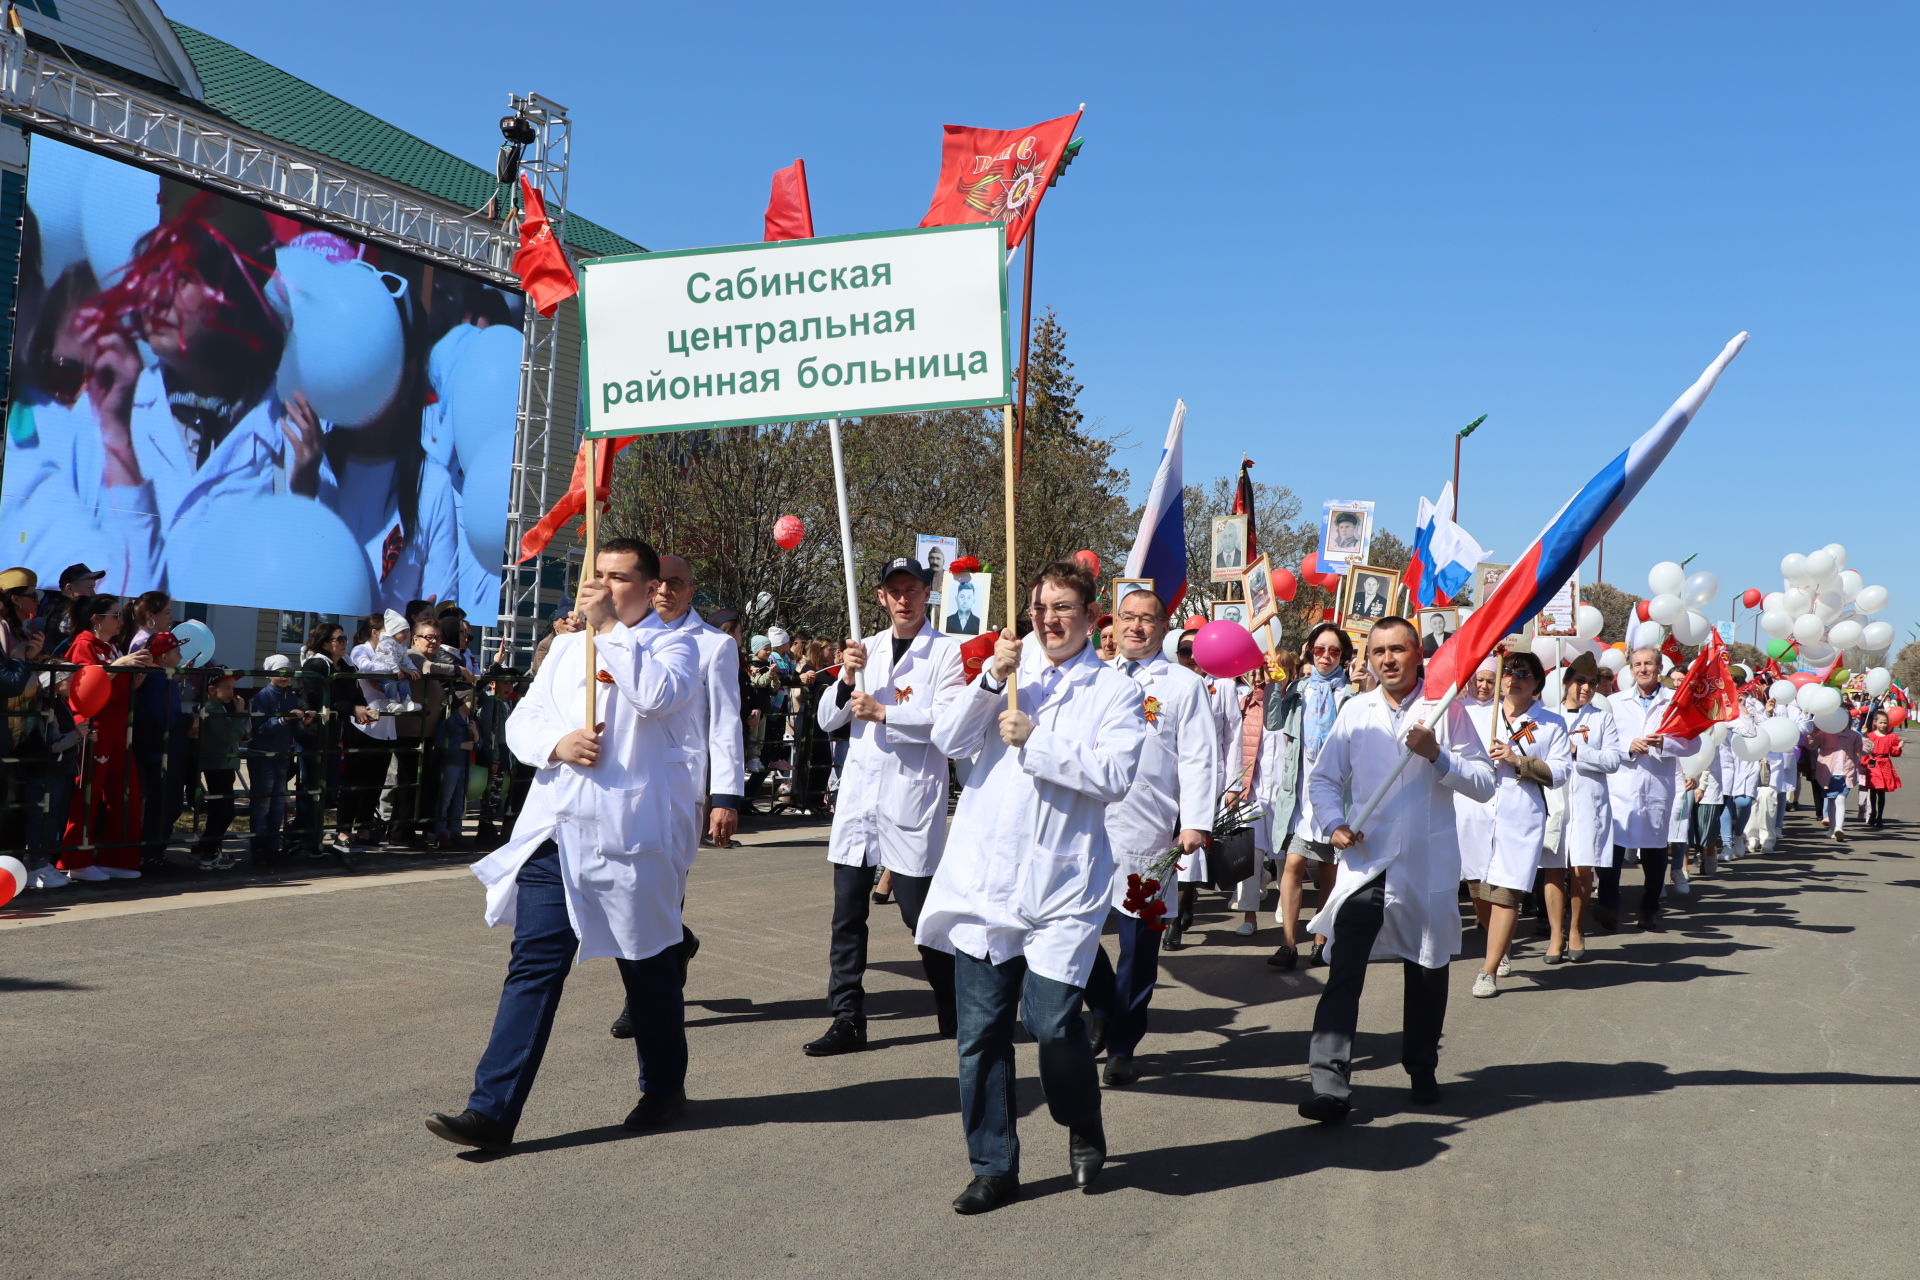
[472,624,701,960]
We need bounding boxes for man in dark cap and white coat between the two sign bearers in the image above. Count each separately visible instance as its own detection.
[803,557,966,1057]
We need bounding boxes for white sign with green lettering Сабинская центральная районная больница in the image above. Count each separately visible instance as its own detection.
[582,223,1012,436]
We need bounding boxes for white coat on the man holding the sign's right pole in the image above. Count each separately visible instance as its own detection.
[918,645,1146,986]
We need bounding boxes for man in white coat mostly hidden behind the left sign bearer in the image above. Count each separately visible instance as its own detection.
[611,555,747,1040]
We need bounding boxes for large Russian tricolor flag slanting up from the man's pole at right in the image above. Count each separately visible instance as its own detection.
[1427,334,1747,699]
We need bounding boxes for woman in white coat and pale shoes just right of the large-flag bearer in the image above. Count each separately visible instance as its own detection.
[1455,652,1572,998]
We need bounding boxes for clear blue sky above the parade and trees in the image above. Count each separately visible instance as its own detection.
[165,0,1920,639]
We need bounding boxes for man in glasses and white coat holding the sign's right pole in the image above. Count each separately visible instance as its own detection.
[920,560,1146,1213]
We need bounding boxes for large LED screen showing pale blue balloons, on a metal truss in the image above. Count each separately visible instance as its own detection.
[0,136,522,626]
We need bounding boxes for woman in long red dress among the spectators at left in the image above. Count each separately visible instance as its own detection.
[60,595,154,881]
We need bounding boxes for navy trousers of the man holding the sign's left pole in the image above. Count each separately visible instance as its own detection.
[467,841,687,1128]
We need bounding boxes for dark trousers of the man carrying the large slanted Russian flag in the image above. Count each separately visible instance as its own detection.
[1308,877,1448,1098]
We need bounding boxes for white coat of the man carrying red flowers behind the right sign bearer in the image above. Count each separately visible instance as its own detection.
[1106,652,1219,915]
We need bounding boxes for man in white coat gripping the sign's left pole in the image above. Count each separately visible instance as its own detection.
[426,537,699,1151]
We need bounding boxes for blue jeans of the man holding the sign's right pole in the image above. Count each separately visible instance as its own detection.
[954,952,1100,1174]
